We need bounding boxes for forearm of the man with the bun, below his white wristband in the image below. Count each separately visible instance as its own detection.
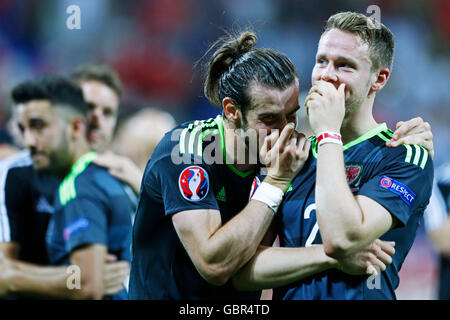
[206,200,275,283]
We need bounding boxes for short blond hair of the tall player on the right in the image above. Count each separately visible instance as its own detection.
[322,12,394,71]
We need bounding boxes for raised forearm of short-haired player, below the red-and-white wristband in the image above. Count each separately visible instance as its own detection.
[315,143,363,257]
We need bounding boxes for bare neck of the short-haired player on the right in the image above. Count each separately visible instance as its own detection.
[341,99,378,144]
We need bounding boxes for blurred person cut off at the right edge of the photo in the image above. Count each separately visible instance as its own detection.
[423,162,450,300]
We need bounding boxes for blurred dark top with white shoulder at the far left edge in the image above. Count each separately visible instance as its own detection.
[0,150,61,265]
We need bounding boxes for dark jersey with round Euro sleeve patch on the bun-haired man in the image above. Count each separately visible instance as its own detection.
[129,116,260,300]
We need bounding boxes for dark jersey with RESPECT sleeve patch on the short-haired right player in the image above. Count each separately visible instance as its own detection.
[274,124,433,300]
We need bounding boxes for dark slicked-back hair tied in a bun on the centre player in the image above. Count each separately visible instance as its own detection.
[204,31,298,114]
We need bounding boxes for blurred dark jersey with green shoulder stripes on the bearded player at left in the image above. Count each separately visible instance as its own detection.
[47,152,133,299]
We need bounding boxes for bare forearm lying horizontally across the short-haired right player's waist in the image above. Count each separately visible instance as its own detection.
[233,245,337,291]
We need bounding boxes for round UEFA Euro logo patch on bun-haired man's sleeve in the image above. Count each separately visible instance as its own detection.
[178,166,209,201]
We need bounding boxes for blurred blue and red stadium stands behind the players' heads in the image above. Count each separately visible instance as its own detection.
[0,0,450,299]
